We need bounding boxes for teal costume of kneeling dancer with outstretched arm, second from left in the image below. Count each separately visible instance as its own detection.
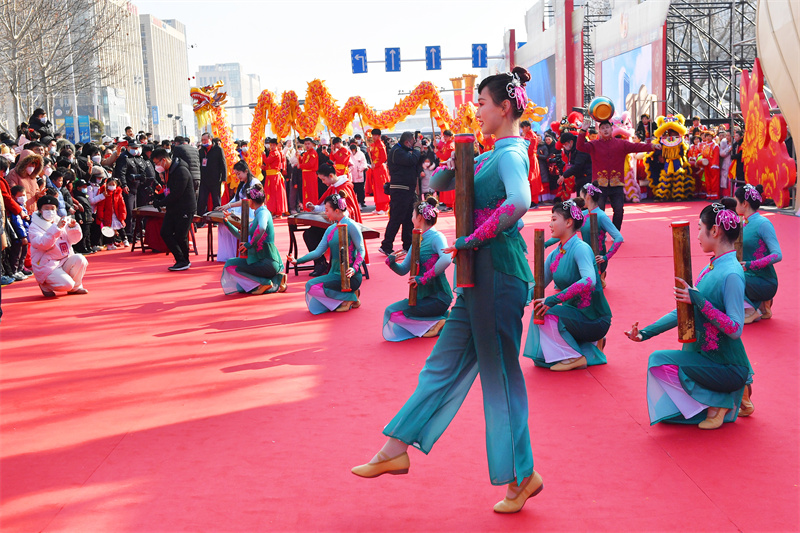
[297,216,364,315]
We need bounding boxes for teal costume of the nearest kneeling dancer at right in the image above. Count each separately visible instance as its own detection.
[640,251,752,424]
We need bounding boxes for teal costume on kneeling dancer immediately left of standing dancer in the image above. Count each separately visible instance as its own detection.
[383,228,453,341]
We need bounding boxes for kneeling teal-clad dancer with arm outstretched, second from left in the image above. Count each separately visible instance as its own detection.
[286,191,364,315]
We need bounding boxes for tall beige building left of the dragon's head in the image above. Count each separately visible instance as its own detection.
[139,15,197,139]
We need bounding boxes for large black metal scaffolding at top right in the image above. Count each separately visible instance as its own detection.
[666,0,756,124]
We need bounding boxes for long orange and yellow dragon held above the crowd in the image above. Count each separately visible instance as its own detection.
[191,80,547,177]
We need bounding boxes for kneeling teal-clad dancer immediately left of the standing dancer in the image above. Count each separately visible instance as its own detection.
[383,197,453,342]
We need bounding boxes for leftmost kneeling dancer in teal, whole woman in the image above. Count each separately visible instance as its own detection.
[220,183,286,294]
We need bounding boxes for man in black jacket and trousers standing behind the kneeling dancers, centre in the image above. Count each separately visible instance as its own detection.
[378,131,421,255]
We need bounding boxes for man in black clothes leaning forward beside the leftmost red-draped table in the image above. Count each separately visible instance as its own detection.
[151,148,197,271]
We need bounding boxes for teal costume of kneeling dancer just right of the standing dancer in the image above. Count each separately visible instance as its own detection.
[524,233,611,368]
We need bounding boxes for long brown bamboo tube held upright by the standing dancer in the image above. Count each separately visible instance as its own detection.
[455,133,475,287]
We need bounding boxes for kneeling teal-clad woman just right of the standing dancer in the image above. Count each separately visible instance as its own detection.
[524,198,611,372]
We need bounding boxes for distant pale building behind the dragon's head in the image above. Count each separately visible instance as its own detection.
[195,63,261,140]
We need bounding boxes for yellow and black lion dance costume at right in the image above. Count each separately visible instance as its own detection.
[644,114,694,201]
